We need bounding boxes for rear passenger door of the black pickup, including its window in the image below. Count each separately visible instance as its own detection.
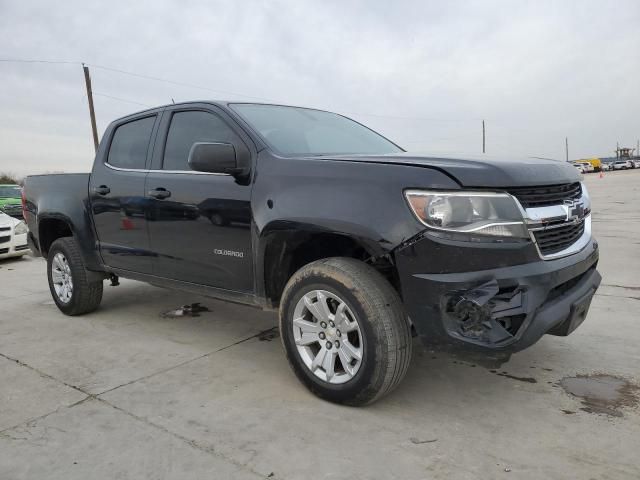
[89,113,159,274]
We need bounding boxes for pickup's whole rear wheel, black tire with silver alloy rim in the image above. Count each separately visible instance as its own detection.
[47,237,102,315]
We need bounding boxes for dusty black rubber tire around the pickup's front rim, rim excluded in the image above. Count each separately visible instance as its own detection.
[280,257,412,406]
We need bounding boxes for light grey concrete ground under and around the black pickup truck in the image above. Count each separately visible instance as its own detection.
[0,171,640,480]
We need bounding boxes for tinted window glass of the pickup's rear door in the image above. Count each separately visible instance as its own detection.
[107,116,156,170]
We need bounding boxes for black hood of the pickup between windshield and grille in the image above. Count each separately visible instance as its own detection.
[312,153,580,187]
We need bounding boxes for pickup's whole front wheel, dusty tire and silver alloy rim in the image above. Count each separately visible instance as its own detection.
[280,257,411,405]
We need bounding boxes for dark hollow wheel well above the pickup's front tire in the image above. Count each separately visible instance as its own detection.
[264,233,399,306]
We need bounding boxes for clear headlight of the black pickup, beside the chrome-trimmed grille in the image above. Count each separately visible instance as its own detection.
[405,190,529,238]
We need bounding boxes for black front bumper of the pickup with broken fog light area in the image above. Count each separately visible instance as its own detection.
[395,234,601,353]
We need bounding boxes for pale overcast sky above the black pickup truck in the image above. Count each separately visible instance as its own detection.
[0,0,640,175]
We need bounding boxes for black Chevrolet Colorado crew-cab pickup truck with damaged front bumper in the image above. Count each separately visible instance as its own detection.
[23,102,600,405]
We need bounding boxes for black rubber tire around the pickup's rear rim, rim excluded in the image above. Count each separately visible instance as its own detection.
[47,237,102,315]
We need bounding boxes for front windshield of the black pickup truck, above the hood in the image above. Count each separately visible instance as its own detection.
[231,103,403,155]
